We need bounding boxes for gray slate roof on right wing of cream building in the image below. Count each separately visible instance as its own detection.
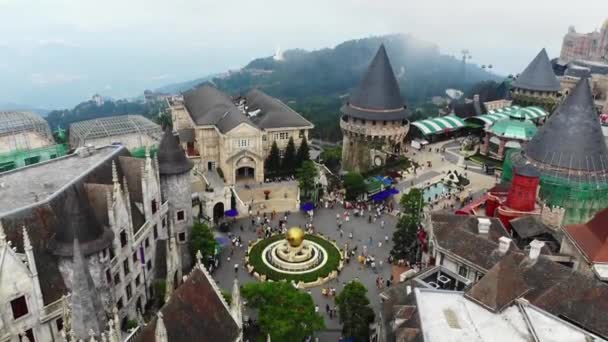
[245,89,313,129]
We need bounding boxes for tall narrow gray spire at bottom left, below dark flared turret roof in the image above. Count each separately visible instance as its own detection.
[70,237,106,341]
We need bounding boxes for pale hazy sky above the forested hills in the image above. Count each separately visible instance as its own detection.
[0,0,608,109]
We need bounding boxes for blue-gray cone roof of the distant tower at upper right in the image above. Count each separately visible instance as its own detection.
[513,48,560,91]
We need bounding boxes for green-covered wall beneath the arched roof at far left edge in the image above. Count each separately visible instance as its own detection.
[0,144,69,172]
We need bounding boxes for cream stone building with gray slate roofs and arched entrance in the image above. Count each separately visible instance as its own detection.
[169,84,314,185]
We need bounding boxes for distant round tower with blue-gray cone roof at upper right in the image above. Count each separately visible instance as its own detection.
[511,48,561,111]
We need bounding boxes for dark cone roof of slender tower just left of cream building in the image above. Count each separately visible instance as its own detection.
[158,128,194,175]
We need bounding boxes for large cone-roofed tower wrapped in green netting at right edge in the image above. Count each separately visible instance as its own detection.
[503,79,608,224]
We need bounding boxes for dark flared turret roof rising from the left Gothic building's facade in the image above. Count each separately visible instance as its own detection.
[50,185,114,256]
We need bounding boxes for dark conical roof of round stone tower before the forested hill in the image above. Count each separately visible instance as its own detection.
[342,44,408,120]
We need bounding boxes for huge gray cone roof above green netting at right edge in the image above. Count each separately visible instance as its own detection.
[525,79,608,172]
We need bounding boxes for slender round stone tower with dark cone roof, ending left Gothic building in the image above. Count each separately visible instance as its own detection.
[158,129,193,270]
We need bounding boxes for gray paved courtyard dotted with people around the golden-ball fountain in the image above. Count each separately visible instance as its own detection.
[213,205,396,341]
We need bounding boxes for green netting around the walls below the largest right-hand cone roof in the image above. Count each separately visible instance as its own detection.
[501,150,608,224]
